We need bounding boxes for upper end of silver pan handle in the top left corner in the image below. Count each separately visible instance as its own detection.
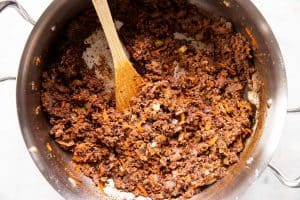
[0,0,35,25]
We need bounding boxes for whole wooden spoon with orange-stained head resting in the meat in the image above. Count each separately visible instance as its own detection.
[92,0,144,111]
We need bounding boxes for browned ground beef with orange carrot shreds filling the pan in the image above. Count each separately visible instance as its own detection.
[41,0,255,199]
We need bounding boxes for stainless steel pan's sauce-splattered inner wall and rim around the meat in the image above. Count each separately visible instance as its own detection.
[17,0,286,199]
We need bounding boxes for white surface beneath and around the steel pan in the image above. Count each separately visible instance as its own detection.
[0,0,300,200]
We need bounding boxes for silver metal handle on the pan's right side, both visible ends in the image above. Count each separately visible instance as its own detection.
[268,107,300,188]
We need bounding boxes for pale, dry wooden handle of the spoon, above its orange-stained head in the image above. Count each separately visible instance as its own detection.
[92,0,128,67]
